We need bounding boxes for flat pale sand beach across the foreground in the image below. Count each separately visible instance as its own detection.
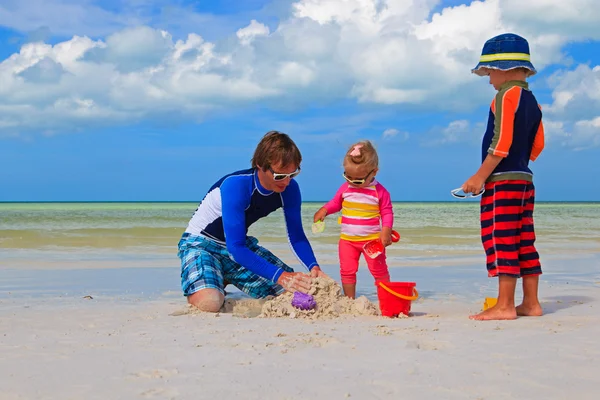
[0,258,600,399]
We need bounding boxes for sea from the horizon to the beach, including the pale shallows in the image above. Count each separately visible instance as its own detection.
[0,201,600,298]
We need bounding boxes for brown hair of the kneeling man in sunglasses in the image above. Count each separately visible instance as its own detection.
[251,131,302,171]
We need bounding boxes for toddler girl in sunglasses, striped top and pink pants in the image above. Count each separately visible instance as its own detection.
[314,140,394,298]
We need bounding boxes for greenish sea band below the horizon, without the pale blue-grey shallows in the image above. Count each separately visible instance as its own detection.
[0,201,600,259]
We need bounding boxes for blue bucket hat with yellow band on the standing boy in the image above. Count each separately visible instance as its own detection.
[471,33,537,76]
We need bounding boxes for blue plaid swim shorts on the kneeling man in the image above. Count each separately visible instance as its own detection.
[177,233,294,299]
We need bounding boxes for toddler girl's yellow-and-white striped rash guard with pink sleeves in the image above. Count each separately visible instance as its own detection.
[323,180,394,242]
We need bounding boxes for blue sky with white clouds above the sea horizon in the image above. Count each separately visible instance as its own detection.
[0,0,600,201]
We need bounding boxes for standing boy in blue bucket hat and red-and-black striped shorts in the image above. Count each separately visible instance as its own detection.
[462,33,544,320]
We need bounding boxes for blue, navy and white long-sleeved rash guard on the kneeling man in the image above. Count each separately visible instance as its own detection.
[185,168,317,282]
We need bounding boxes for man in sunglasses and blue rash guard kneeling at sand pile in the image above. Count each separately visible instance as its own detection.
[178,131,325,312]
